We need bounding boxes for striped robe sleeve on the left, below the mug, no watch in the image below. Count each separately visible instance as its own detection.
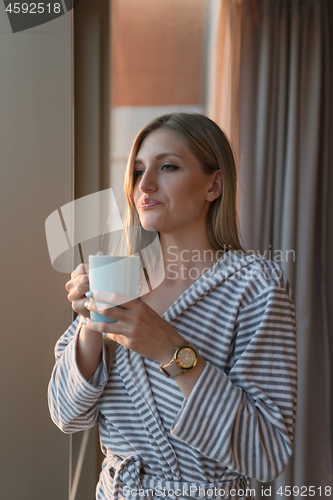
[48,318,108,434]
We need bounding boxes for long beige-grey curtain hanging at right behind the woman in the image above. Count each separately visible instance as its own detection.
[209,0,333,500]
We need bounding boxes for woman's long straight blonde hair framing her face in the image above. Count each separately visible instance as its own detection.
[124,113,244,251]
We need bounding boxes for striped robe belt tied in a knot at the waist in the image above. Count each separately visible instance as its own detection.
[103,453,250,500]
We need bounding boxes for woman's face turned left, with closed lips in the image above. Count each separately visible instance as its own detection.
[134,128,216,233]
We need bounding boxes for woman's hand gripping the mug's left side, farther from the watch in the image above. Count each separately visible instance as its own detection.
[65,264,90,318]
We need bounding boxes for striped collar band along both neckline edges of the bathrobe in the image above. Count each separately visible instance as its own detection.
[117,250,263,481]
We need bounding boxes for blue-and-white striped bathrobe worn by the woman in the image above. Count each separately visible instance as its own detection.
[48,251,297,500]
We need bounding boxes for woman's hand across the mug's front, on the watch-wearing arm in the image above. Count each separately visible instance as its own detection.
[86,291,186,363]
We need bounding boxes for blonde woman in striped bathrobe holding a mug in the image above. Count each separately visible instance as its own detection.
[49,113,296,499]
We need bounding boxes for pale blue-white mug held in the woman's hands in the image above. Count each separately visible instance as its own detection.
[89,255,140,323]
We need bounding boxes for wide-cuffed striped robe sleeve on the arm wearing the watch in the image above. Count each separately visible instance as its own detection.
[171,286,297,482]
